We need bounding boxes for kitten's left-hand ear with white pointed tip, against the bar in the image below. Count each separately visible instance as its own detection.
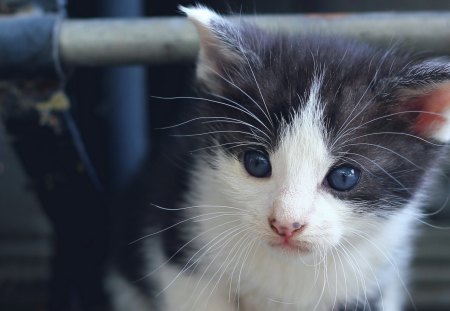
[179,5,259,93]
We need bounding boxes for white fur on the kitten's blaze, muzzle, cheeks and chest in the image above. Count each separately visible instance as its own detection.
[152,80,416,311]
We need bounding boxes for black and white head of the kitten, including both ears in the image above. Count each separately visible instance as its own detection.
[182,7,450,252]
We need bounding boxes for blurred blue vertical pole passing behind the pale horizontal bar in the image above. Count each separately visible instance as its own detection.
[101,0,148,189]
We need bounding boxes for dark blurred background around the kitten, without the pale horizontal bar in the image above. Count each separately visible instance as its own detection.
[0,0,450,311]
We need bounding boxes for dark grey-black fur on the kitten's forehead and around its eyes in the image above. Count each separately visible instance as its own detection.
[194,24,450,215]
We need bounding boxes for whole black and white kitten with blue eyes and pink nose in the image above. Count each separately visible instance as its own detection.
[109,6,450,311]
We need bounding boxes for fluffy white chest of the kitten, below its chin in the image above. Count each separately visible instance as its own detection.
[227,248,383,311]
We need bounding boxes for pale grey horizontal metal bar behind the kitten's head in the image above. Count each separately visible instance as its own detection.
[59,12,450,66]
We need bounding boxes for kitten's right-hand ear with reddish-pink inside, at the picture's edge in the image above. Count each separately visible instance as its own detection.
[391,58,450,143]
